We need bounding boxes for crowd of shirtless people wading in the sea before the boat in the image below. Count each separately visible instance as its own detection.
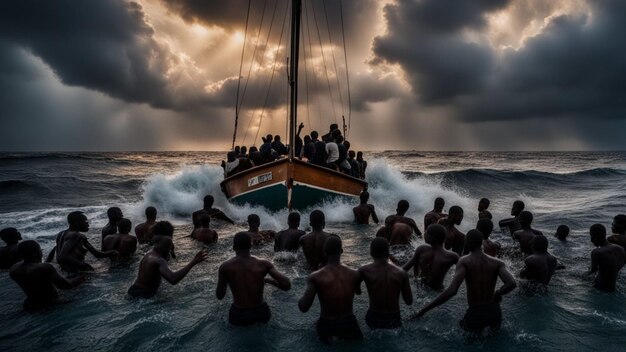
[0,195,626,342]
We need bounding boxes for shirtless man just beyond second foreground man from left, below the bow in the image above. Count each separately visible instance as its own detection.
[300,210,330,270]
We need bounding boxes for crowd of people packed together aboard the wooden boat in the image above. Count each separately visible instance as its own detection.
[222,123,367,179]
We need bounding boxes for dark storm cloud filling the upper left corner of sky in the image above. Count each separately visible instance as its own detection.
[0,0,210,109]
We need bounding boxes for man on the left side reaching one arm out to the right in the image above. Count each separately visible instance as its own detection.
[128,221,208,298]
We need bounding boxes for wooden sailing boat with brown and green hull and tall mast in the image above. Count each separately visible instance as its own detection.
[221,0,367,210]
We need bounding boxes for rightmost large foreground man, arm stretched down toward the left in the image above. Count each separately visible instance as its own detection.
[416,230,517,333]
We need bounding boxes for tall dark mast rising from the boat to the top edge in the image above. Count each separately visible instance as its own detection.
[289,0,302,160]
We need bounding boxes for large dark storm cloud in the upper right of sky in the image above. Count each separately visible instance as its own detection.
[373,0,626,121]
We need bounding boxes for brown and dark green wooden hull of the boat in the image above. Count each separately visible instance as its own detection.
[221,159,367,211]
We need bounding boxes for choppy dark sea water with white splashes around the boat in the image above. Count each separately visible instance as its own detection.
[0,151,626,351]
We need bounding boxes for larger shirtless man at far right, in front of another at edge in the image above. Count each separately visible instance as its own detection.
[589,224,626,292]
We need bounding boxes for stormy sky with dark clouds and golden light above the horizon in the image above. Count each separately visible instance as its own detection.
[0,0,626,151]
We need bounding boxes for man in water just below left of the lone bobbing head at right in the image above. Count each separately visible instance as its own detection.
[520,236,557,285]
